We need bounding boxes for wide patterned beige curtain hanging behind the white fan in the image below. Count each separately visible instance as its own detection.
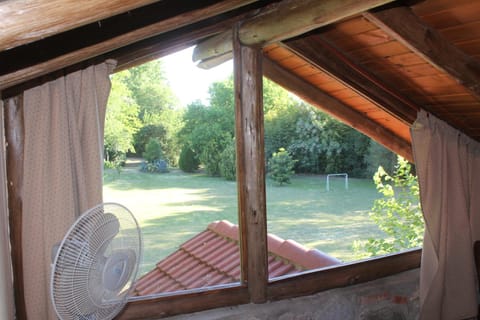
[22,61,115,320]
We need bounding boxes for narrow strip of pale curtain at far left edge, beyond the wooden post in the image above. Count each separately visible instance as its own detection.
[0,100,14,319]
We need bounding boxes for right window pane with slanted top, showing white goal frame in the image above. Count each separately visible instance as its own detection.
[264,81,423,278]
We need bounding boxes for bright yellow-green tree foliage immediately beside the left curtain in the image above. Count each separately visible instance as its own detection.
[104,71,140,162]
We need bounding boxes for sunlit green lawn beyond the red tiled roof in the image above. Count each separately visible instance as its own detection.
[104,168,381,273]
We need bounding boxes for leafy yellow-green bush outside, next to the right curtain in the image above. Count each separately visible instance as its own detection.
[354,156,424,257]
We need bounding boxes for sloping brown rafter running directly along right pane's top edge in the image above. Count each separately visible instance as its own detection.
[263,58,413,163]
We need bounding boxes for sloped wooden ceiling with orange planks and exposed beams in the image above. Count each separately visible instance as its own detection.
[0,0,480,160]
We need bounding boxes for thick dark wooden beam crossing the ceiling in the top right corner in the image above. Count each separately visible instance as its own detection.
[364,7,480,97]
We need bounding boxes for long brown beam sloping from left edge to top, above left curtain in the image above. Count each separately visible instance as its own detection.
[0,0,254,90]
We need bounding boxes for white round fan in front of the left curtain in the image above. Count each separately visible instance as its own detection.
[50,203,142,320]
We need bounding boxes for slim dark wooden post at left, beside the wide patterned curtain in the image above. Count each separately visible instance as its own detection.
[4,95,27,320]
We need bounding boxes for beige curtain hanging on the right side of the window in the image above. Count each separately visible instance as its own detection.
[411,111,480,320]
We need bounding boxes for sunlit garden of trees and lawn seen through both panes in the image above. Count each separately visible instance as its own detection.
[104,60,423,272]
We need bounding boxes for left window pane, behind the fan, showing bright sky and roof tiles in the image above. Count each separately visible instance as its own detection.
[104,49,240,295]
